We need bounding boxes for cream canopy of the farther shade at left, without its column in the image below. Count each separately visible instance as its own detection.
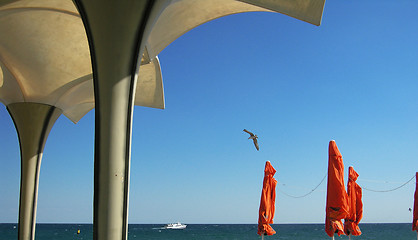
[0,0,164,123]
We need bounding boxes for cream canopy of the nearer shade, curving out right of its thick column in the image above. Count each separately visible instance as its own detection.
[146,0,325,62]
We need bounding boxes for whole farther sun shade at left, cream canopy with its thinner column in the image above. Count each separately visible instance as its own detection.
[0,1,164,239]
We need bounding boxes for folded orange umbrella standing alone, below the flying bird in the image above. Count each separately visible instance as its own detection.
[257,161,277,236]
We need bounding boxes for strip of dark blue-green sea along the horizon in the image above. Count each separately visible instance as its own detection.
[0,223,417,240]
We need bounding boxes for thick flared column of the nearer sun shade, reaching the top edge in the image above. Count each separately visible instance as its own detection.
[74,0,168,240]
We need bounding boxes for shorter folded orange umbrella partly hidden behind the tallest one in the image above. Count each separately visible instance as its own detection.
[344,167,363,236]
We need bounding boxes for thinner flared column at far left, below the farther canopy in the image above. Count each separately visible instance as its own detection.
[7,103,62,240]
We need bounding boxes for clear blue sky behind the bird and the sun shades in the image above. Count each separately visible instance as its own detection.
[0,0,418,223]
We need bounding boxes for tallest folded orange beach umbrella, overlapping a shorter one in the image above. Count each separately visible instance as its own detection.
[325,141,349,237]
